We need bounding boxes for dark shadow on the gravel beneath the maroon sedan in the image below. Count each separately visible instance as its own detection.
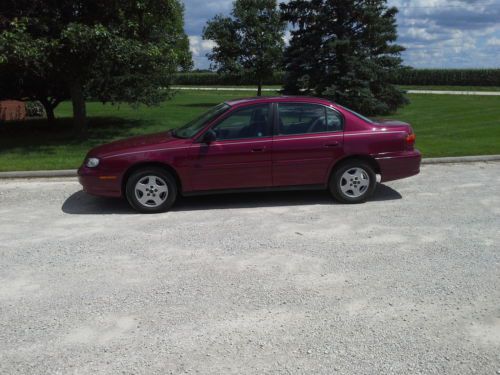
[61,184,402,215]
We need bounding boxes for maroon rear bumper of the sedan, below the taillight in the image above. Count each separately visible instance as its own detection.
[375,150,422,182]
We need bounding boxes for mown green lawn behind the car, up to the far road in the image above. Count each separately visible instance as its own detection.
[0,91,500,171]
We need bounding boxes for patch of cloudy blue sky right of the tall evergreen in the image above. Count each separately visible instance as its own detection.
[389,0,500,68]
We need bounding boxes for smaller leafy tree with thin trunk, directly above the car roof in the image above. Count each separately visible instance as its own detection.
[203,0,285,96]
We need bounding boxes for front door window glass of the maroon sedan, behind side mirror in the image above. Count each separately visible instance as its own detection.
[213,104,271,140]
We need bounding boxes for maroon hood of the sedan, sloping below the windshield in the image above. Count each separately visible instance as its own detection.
[89,132,180,157]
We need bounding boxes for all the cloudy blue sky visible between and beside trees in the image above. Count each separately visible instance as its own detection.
[184,0,500,69]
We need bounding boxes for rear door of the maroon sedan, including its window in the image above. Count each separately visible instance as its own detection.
[273,102,343,186]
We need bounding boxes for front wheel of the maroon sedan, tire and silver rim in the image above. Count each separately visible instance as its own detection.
[125,167,178,213]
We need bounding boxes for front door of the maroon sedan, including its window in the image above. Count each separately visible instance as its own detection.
[190,103,272,191]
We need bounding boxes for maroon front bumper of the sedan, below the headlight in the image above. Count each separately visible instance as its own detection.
[78,166,122,197]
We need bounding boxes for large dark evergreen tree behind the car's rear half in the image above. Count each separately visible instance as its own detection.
[281,0,407,114]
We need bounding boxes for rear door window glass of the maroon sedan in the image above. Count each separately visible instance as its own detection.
[278,103,342,135]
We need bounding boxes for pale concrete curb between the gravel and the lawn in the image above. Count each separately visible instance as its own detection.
[0,155,500,179]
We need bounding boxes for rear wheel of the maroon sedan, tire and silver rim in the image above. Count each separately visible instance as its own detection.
[328,160,377,203]
